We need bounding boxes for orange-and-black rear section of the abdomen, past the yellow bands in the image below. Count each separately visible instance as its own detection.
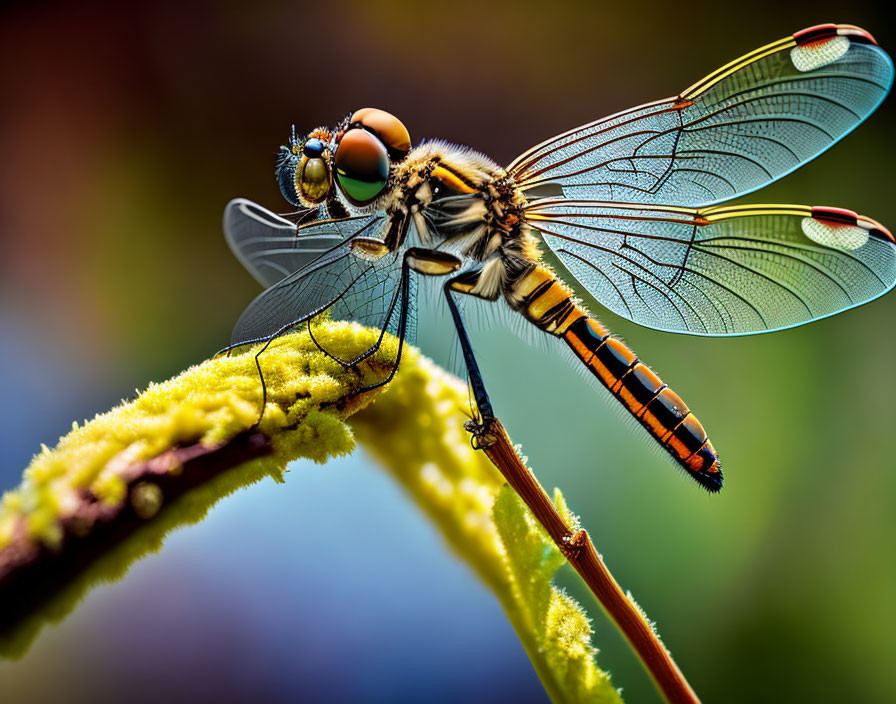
[563,315,722,492]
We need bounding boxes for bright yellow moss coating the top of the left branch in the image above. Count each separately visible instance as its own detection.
[0,321,390,549]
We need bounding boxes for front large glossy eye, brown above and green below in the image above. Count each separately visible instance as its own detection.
[335,129,389,205]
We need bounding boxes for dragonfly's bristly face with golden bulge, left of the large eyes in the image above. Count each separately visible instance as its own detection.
[277,127,333,208]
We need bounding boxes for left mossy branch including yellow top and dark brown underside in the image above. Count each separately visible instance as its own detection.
[0,321,392,656]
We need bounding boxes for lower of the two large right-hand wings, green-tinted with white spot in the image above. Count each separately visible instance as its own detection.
[526,199,896,336]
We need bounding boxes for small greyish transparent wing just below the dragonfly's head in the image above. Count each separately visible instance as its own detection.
[224,198,380,286]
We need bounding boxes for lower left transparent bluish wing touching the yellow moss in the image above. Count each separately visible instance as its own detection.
[231,212,416,352]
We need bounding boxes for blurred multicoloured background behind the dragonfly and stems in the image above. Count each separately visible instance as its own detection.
[0,0,896,702]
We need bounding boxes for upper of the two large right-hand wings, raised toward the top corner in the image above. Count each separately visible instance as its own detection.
[508,25,893,206]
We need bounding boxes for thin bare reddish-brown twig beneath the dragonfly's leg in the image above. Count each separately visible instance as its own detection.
[467,418,700,704]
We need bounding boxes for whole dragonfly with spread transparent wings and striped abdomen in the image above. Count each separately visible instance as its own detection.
[224,24,896,492]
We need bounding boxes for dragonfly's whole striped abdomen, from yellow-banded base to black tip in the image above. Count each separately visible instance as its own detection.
[508,266,722,492]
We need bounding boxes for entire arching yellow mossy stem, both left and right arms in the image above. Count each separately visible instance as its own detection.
[0,321,621,704]
